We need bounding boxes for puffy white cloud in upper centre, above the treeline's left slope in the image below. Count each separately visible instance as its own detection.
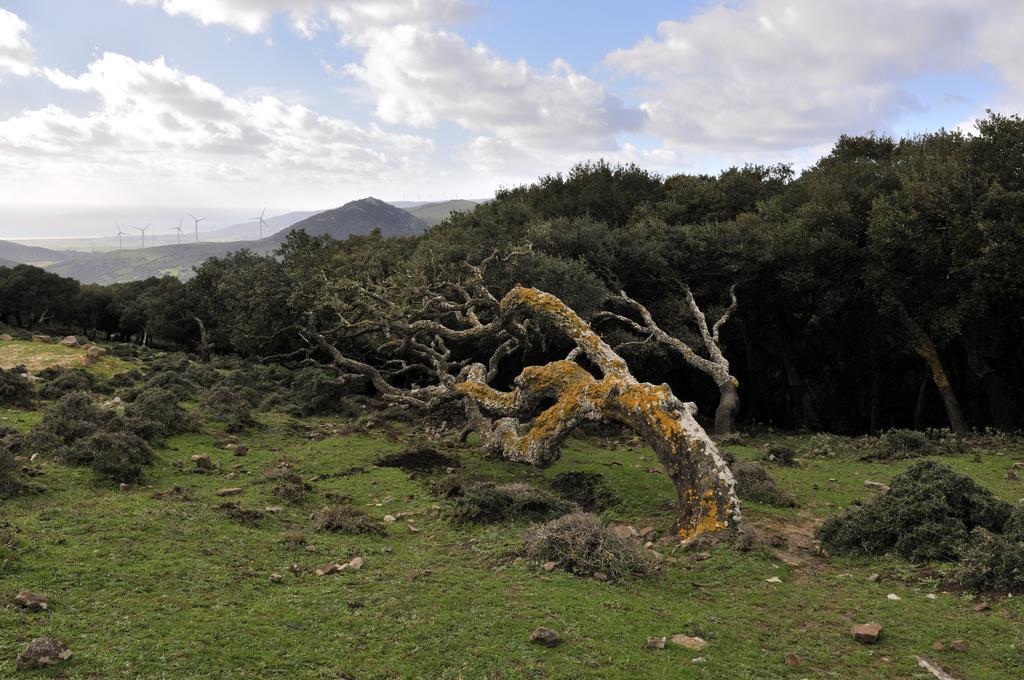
[347,26,643,153]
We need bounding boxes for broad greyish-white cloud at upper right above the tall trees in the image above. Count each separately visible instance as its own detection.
[606,0,1024,151]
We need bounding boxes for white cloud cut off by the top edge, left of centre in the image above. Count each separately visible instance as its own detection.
[125,0,474,36]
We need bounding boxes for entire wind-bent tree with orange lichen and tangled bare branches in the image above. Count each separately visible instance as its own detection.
[305,256,740,539]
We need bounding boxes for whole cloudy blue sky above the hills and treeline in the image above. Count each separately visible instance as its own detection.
[0,0,1024,239]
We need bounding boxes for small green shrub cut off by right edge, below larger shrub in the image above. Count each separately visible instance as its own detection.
[952,526,1024,592]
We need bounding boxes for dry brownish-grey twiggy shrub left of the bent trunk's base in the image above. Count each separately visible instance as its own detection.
[523,512,658,581]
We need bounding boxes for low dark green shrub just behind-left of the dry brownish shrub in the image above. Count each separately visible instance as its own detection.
[452,481,571,522]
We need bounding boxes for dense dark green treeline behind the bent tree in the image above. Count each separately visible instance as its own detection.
[0,114,1024,432]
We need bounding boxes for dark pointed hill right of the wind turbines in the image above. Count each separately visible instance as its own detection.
[265,197,427,243]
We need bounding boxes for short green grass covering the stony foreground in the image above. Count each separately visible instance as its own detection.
[0,399,1024,680]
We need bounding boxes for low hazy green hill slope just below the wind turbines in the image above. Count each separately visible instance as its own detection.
[46,240,274,284]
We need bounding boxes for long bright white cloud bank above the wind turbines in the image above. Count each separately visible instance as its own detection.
[0,53,432,200]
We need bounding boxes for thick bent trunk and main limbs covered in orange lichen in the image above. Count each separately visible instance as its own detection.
[454,287,740,539]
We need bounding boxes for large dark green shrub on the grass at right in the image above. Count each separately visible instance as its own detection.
[818,461,1011,560]
